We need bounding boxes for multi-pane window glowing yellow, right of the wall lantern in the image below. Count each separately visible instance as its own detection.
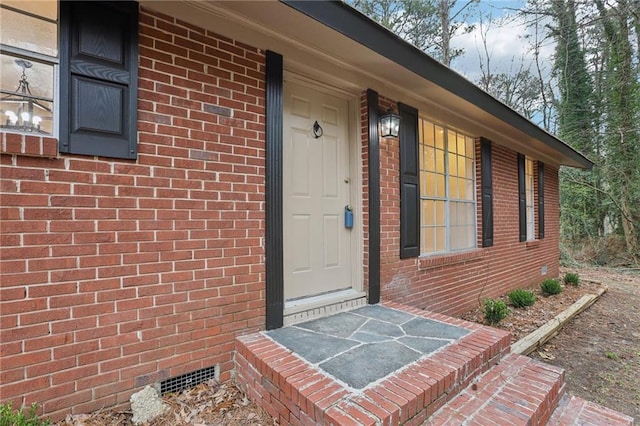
[418,119,476,254]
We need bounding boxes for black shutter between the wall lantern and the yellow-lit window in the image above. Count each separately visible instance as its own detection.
[398,103,420,259]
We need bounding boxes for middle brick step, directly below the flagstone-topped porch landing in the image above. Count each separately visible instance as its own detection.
[425,354,564,426]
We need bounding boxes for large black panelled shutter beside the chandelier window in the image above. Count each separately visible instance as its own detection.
[60,1,138,158]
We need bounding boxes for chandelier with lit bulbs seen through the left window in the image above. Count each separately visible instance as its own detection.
[0,59,51,133]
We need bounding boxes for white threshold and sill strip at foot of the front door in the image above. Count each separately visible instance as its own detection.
[284,289,367,325]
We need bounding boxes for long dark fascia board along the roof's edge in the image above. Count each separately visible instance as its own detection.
[280,0,593,169]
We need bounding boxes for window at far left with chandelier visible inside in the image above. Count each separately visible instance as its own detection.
[0,0,58,135]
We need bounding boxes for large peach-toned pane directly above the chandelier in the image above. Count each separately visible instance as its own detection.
[0,2,58,56]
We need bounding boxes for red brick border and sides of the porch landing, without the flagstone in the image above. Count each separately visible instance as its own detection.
[235,304,510,426]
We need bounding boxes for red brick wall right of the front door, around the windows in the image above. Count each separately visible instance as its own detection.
[363,96,559,314]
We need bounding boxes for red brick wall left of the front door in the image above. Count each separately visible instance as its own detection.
[0,9,265,418]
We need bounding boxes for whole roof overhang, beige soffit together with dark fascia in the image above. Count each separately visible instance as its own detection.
[141,0,593,168]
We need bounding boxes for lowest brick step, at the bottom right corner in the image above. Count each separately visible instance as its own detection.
[548,394,634,426]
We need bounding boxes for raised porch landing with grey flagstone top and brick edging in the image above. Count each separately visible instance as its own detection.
[235,303,510,425]
